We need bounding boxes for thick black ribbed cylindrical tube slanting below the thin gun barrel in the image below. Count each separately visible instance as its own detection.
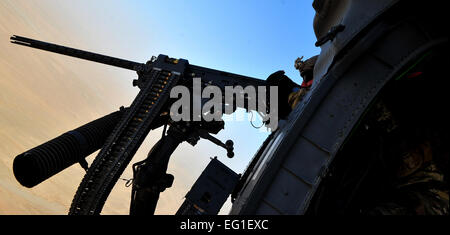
[13,111,124,188]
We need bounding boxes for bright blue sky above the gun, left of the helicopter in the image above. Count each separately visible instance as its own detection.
[134,0,318,82]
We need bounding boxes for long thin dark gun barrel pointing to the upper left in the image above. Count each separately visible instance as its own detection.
[11,35,145,71]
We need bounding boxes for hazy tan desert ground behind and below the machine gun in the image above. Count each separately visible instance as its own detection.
[0,0,200,214]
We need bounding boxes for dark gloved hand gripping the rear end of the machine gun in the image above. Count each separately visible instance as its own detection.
[266,70,300,119]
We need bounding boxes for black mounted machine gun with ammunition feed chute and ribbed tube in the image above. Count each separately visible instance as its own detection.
[11,36,269,215]
